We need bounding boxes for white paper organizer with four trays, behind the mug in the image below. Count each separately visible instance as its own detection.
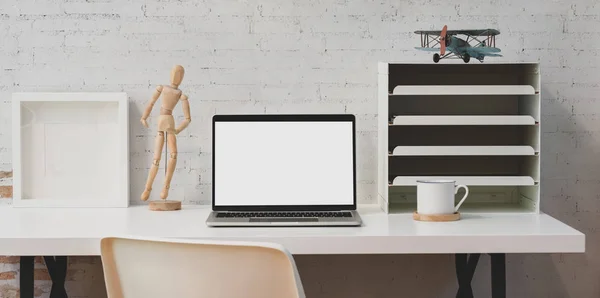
[377,63,541,214]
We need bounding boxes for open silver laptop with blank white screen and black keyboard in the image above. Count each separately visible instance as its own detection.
[206,114,361,226]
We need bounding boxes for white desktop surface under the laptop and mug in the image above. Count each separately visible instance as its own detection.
[0,205,585,256]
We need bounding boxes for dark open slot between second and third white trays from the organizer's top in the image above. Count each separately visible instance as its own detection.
[387,125,540,152]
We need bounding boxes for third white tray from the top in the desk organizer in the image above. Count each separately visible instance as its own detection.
[391,146,536,156]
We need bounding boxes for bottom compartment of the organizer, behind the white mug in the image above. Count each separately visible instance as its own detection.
[389,185,539,213]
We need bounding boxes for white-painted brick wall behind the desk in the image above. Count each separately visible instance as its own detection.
[0,0,600,297]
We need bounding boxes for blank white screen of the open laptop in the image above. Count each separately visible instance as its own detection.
[213,121,354,206]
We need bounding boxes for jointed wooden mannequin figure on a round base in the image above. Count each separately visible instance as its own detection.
[140,65,192,210]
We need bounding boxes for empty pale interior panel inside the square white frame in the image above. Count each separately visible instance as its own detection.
[20,101,121,200]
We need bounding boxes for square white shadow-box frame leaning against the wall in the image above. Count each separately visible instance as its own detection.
[12,92,129,207]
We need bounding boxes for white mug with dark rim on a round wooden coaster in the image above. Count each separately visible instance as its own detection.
[417,180,469,214]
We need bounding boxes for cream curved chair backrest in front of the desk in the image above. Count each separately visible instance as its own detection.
[101,238,305,298]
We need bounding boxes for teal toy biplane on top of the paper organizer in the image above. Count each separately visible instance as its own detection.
[415,26,502,63]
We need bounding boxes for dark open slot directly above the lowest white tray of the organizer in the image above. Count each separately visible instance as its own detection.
[386,155,540,181]
